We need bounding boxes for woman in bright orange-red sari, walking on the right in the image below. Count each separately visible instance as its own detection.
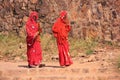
[52,11,73,66]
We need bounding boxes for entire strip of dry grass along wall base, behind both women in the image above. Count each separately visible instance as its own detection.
[0,34,96,61]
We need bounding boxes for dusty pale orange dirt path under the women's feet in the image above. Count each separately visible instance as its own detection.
[0,47,120,80]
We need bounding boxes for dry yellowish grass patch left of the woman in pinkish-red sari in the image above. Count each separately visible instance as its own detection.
[0,34,26,60]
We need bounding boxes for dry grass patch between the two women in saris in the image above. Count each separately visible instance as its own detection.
[41,34,58,61]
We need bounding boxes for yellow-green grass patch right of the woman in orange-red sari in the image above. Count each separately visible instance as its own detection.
[70,38,98,55]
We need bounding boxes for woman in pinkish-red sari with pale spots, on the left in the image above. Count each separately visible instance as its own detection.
[26,11,42,68]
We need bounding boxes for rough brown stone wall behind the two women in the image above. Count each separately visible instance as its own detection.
[0,0,120,41]
